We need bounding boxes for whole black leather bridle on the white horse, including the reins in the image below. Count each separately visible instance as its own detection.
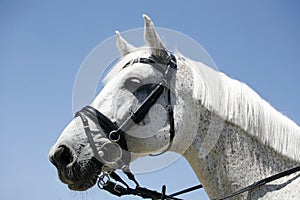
[75,54,300,200]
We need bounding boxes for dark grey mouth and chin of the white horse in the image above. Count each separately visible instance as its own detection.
[59,158,102,191]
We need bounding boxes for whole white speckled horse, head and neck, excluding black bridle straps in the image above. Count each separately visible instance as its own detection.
[49,15,300,199]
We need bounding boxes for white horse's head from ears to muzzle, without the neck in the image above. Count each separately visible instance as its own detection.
[49,15,188,191]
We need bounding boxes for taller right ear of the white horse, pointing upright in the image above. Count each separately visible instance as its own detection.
[143,14,170,63]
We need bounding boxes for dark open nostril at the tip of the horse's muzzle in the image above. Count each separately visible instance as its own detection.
[50,145,74,168]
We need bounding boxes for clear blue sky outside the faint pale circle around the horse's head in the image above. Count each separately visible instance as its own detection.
[0,0,300,200]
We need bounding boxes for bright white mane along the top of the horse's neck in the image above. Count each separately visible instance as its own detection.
[183,52,300,161]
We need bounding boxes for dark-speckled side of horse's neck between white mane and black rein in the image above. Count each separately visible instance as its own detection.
[173,55,299,198]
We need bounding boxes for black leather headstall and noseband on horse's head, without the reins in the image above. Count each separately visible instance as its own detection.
[75,54,177,171]
